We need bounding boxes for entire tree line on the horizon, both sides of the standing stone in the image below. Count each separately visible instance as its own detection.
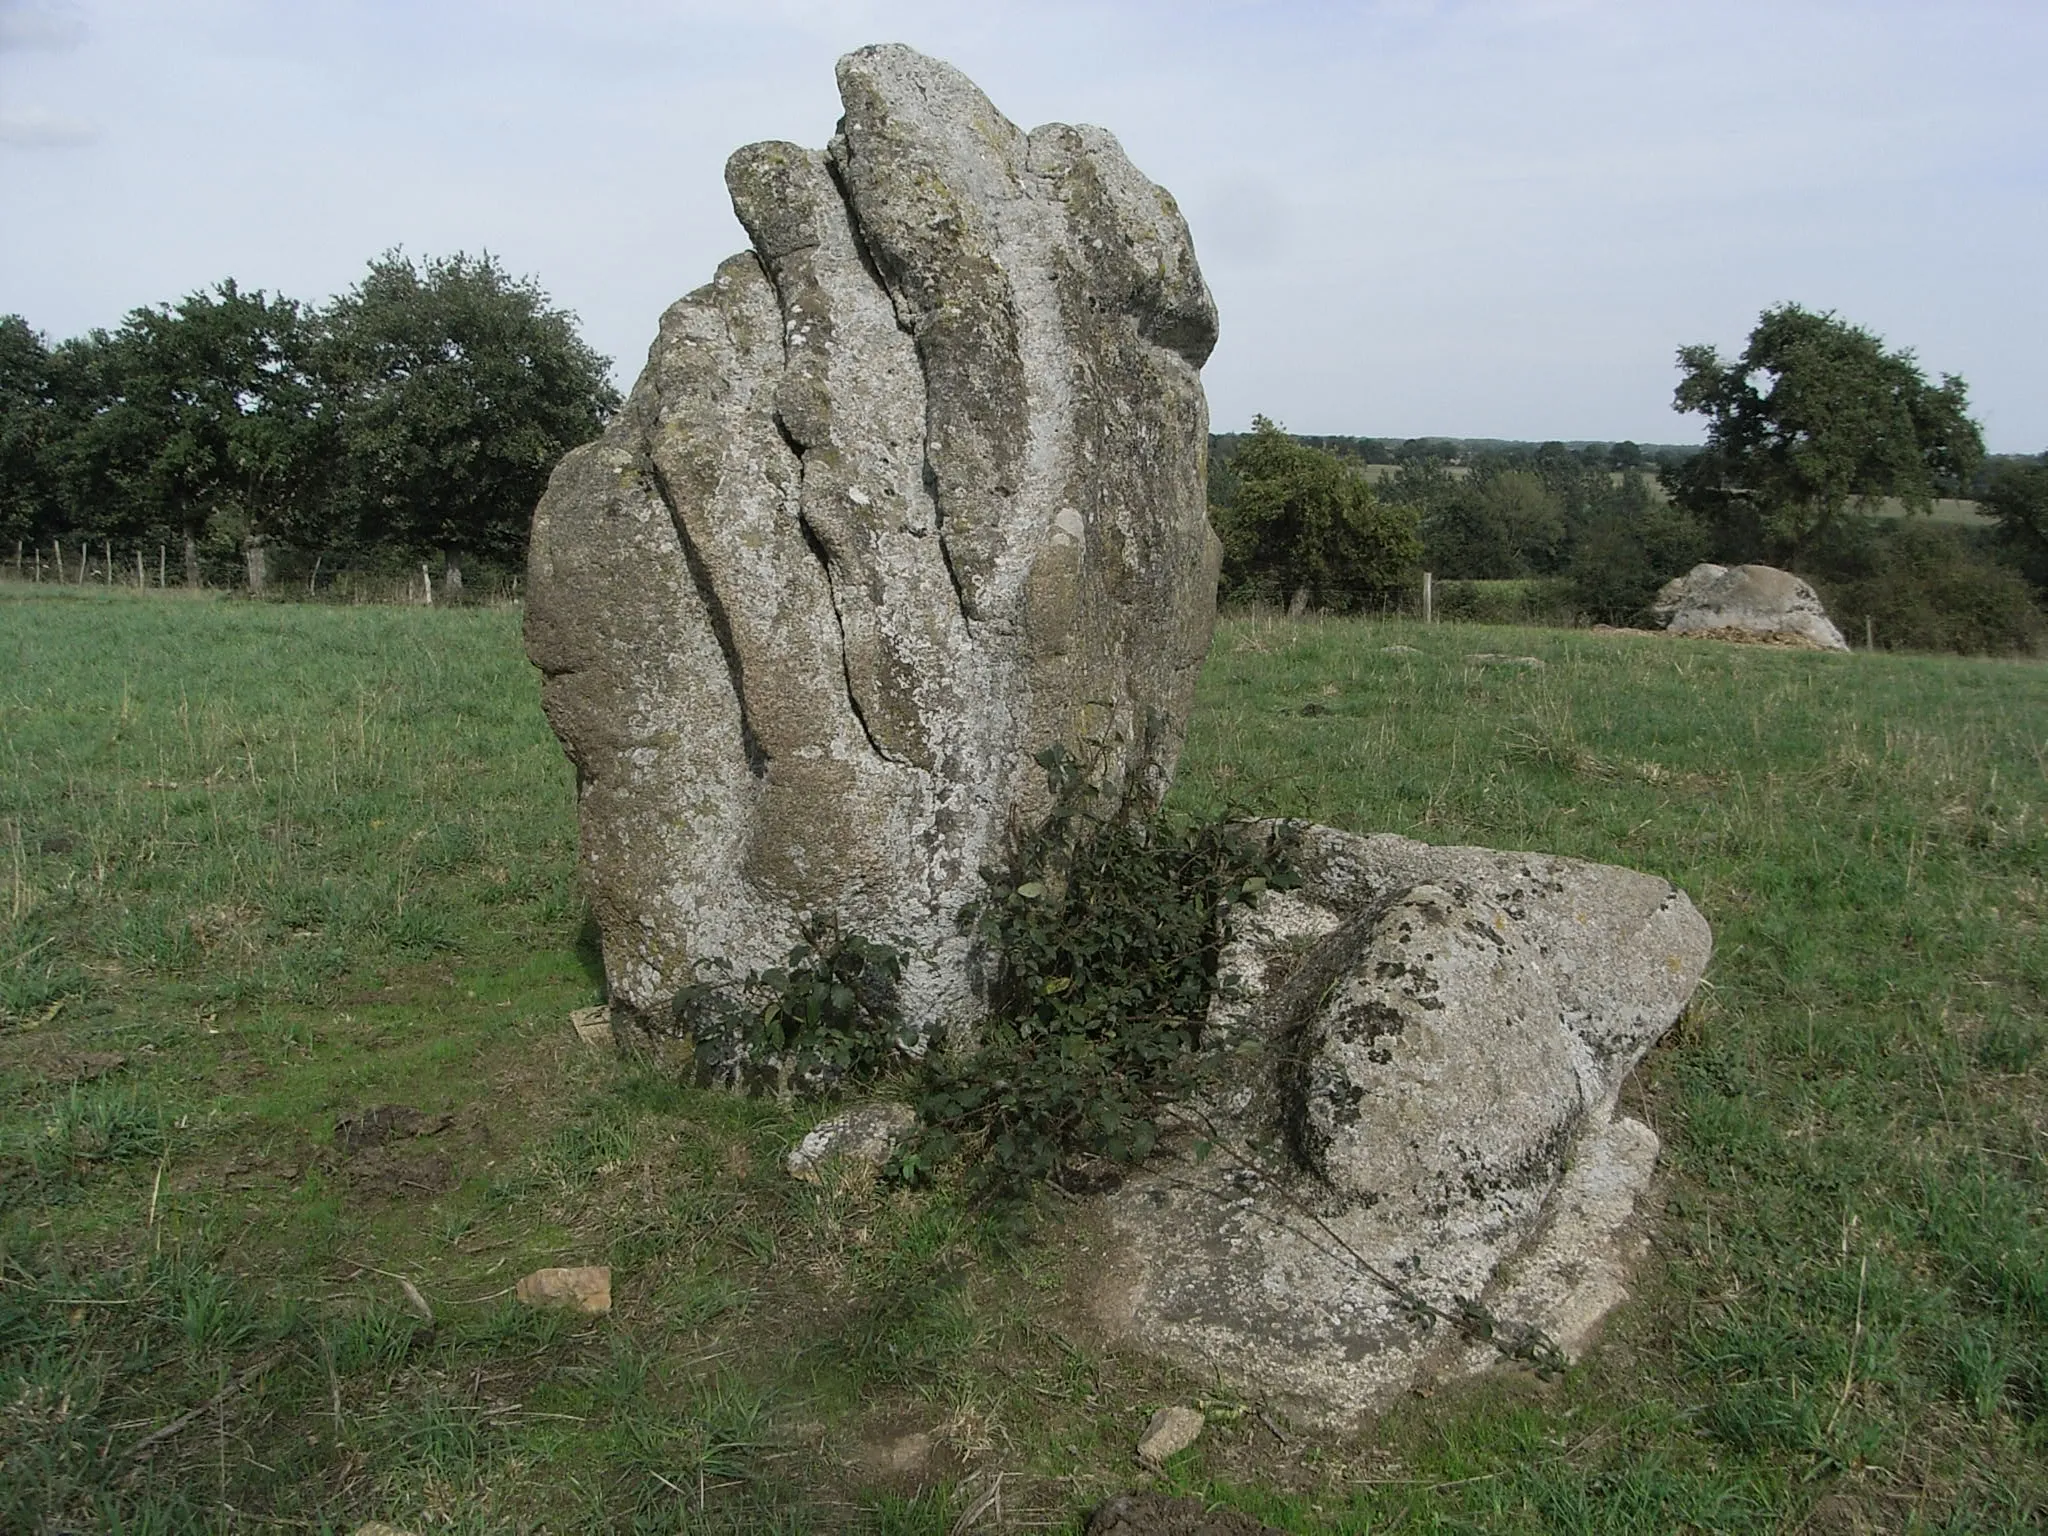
[0,274,2048,649]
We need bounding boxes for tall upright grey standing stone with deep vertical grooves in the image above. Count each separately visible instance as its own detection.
[526,47,1217,1028]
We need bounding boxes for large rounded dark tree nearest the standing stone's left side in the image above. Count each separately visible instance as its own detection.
[319,252,618,586]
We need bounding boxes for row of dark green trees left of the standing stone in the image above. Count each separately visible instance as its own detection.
[0,252,618,592]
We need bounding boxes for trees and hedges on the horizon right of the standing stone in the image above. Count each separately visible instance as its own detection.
[1210,305,2048,651]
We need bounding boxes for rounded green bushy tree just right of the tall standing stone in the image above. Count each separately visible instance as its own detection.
[1217,416,1421,608]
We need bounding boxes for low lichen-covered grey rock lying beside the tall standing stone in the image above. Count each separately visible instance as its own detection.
[1098,823,1712,1423]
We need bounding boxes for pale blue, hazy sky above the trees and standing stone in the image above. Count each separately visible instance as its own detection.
[0,0,2048,453]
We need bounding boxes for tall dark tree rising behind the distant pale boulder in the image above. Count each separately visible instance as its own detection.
[1673,303,1985,559]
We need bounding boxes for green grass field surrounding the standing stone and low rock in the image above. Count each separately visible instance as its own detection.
[0,588,2048,1536]
